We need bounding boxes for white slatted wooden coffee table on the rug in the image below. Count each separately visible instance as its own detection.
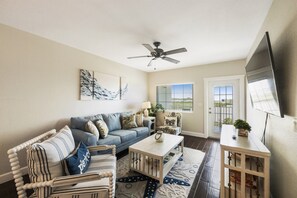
[129,134,184,184]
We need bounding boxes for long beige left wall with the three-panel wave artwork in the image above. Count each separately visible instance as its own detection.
[0,25,147,181]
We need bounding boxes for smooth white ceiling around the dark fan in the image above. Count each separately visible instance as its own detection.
[0,0,272,72]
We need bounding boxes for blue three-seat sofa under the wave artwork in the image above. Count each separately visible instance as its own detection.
[70,112,151,153]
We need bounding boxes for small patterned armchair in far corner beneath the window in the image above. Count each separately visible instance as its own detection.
[155,111,182,135]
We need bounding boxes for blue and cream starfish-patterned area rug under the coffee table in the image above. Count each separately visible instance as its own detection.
[116,147,205,198]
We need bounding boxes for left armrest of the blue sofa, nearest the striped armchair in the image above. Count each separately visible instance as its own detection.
[71,129,97,146]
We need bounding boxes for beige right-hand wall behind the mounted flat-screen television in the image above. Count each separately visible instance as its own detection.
[247,0,297,198]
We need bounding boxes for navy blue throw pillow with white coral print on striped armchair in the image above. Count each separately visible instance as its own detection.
[65,142,91,175]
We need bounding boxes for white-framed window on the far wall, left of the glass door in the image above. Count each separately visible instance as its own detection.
[157,84,193,111]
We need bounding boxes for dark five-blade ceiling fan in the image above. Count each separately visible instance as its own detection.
[127,42,187,66]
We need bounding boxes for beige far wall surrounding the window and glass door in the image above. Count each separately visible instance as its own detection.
[148,60,245,136]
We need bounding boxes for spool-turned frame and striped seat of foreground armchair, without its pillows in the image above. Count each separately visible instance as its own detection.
[7,127,116,198]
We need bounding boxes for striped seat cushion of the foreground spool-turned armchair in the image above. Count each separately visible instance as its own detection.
[52,154,116,198]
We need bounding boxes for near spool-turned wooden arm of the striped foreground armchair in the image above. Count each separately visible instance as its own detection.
[23,171,113,189]
